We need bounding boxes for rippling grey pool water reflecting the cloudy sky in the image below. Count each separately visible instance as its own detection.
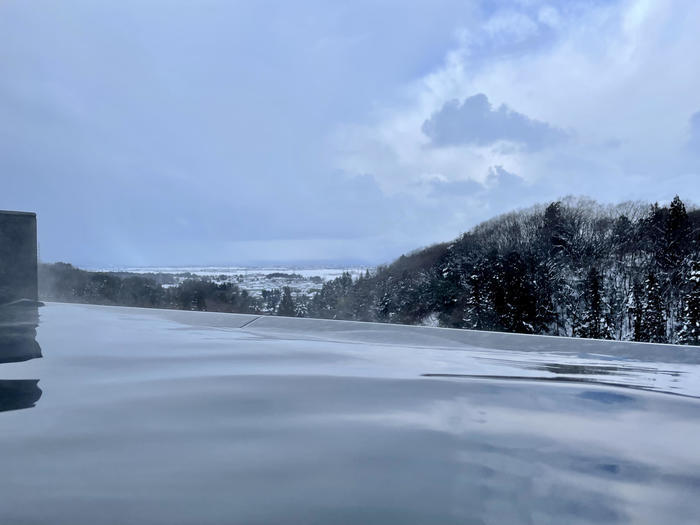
[0,305,700,525]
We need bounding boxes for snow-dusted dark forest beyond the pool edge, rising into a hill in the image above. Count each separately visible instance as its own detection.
[40,197,700,344]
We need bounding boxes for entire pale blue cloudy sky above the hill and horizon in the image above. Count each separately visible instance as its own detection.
[0,0,700,267]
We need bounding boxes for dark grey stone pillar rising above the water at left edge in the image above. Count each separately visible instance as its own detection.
[0,211,38,304]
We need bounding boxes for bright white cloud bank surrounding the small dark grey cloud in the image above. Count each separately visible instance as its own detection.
[336,0,700,209]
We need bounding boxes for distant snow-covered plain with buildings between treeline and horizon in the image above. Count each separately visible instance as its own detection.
[94,266,372,295]
